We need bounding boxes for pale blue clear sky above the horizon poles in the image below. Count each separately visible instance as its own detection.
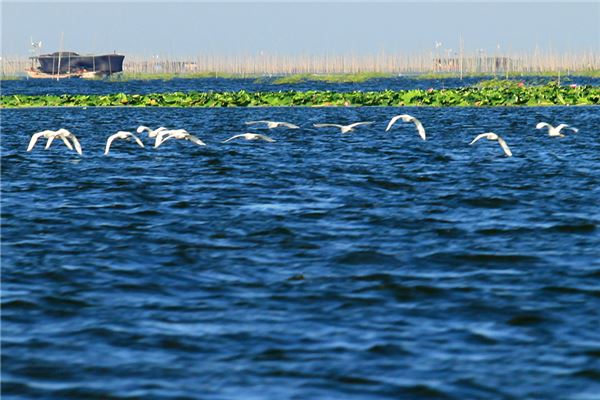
[0,0,600,57]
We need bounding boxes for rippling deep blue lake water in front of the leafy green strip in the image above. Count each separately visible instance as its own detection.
[1,98,600,400]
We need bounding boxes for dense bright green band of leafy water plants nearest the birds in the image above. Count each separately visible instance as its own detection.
[0,83,600,108]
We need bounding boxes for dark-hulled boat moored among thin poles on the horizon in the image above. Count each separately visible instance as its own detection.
[32,51,125,76]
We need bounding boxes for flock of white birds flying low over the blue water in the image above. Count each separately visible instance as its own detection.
[27,114,578,157]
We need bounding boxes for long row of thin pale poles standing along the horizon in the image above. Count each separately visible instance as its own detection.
[0,51,600,76]
